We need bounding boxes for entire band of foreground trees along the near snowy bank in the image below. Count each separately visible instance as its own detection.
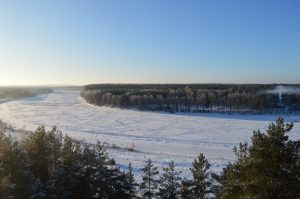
[0,118,300,199]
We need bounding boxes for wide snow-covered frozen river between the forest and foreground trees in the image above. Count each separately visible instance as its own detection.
[0,91,300,178]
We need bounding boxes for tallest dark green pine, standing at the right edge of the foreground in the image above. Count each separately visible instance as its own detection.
[247,118,300,199]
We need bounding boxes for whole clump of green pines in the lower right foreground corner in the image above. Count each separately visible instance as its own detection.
[218,118,300,199]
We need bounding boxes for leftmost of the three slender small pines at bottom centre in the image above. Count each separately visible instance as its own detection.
[140,159,159,199]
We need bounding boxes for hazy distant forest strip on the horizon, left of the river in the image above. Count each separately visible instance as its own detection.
[0,87,52,102]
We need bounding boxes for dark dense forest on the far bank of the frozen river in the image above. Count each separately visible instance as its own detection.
[81,84,300,113]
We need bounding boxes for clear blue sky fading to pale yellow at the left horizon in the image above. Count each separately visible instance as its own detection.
[0,0,300,85]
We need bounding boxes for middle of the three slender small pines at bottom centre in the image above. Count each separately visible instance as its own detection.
[159,161,181,199]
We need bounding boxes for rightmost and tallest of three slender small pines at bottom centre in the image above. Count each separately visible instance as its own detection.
[191,153,212,199]
